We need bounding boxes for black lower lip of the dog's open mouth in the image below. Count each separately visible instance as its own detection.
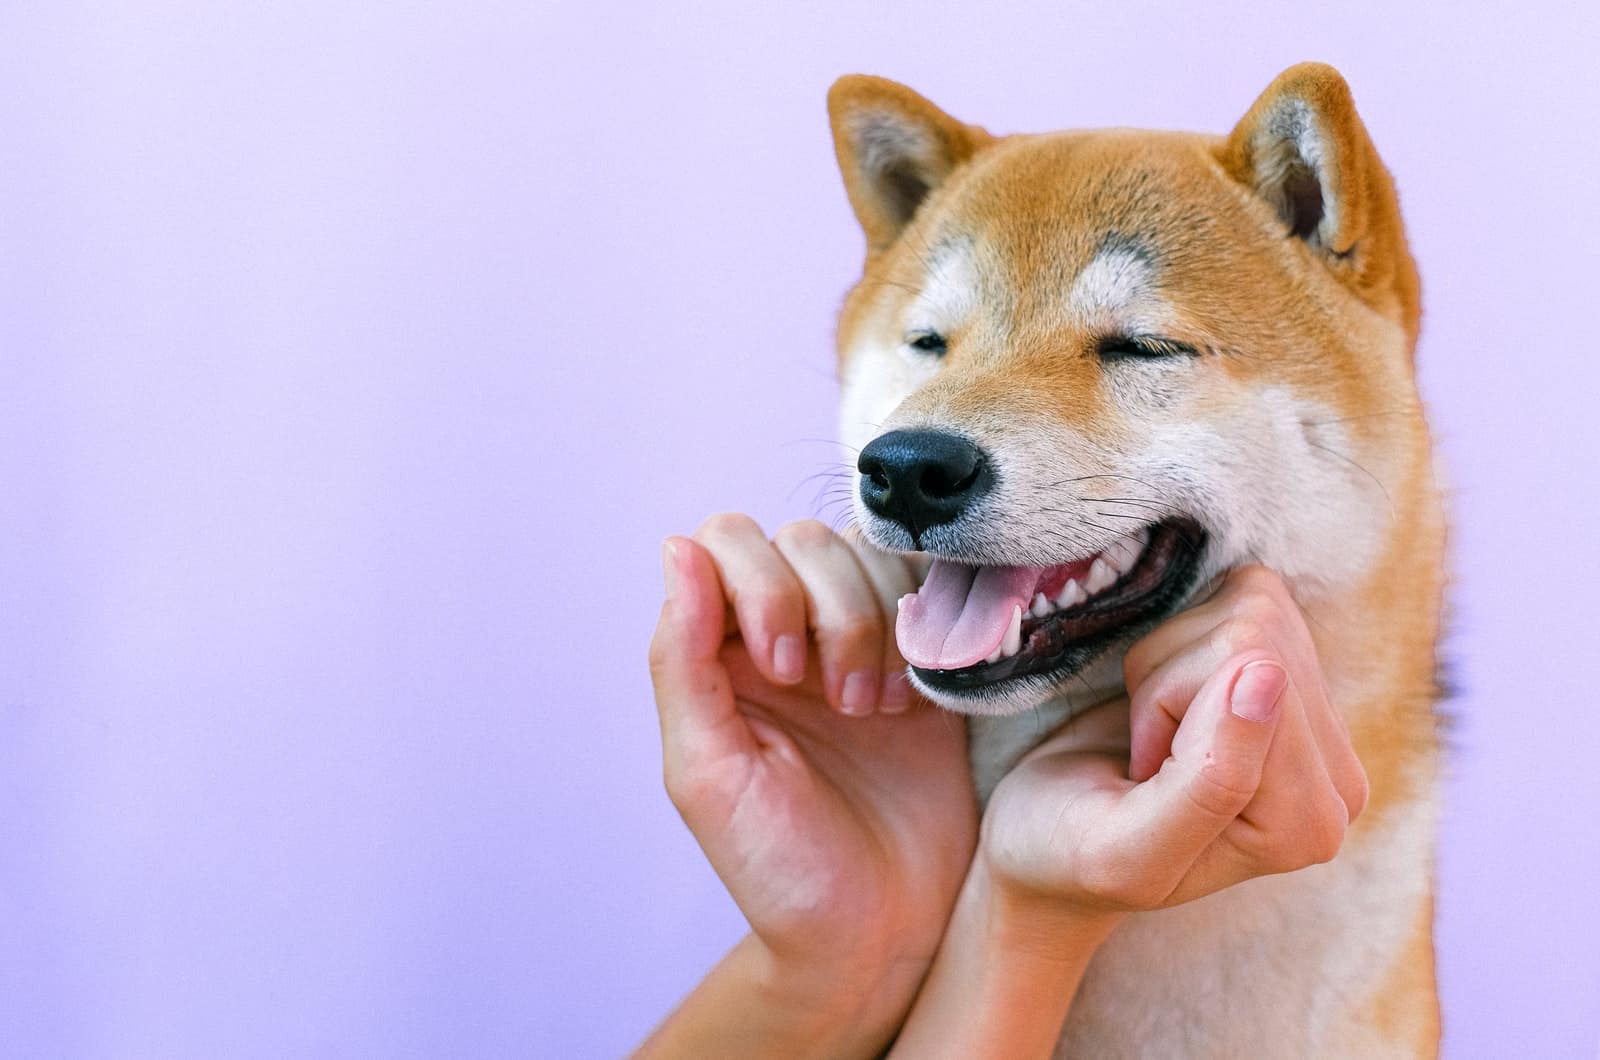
[912,519,1206,695]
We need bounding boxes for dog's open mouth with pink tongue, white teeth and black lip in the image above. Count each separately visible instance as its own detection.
[894,519,1205,693]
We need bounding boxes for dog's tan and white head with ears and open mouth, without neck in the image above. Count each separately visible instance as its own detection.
[829,66,1418,714]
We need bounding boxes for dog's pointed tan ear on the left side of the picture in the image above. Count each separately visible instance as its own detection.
[827,74,992,255]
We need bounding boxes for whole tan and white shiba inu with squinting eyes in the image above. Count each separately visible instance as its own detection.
[829,64,1445,1057]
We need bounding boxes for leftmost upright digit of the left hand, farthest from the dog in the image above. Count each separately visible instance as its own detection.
[650,536,754,809]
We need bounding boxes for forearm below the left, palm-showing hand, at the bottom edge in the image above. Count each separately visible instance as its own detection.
[635,935,922,1058]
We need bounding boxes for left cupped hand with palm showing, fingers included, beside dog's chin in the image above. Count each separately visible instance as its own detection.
[650,516,978,1018]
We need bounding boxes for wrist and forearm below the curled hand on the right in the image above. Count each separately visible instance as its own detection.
[891,858,1117,1058]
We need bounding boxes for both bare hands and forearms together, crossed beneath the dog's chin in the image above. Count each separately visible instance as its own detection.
[640,516,1366,1057]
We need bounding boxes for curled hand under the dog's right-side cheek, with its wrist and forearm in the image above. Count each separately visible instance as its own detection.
[894,567,1368,1057]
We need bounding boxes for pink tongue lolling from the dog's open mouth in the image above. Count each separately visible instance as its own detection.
[894,559,1042,669]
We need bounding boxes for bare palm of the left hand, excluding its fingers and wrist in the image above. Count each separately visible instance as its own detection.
[706,640,976,973]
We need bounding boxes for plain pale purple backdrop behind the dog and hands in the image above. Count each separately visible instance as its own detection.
[0,0,1600,1057]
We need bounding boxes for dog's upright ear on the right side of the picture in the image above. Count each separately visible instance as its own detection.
[1219,62,1421,341]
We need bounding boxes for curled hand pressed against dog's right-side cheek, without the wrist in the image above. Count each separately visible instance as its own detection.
[982,567,1366,916]
